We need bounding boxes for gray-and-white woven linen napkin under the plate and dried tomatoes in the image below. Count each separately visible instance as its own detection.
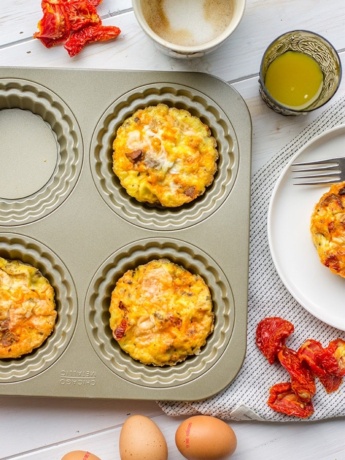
[158,97,345,422]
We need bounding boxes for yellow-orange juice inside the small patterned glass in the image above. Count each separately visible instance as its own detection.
[265,51,323,110]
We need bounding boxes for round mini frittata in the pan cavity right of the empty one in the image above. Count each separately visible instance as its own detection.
[113,104,219,207]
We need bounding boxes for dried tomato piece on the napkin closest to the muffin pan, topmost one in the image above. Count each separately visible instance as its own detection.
[256,316,294,364]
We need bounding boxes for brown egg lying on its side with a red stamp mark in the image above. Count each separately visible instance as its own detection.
[175,415,237,460]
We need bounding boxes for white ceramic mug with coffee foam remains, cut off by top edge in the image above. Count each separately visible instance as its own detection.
[132,0,246,58]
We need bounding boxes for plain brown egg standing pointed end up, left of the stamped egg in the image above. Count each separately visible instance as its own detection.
[119,415,168,460]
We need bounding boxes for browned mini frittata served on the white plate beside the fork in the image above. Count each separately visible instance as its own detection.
[310,182,345,278]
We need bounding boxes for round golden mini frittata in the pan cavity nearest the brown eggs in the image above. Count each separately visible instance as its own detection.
[109,259,214,366]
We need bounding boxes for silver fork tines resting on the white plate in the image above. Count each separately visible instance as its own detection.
[291,157,345,185]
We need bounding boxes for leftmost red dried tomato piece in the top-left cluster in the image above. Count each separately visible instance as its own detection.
[34,0,70,48]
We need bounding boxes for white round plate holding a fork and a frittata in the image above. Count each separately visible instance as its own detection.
[268,126,345,331]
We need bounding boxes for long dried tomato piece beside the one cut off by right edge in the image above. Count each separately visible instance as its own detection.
[297,339,342,393]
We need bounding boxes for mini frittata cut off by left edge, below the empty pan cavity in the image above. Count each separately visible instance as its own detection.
[0,257,57,359]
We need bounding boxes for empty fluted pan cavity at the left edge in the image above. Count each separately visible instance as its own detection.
[0,79,83,225]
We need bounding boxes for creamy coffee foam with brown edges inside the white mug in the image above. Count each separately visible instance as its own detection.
[141,0,233,46]
